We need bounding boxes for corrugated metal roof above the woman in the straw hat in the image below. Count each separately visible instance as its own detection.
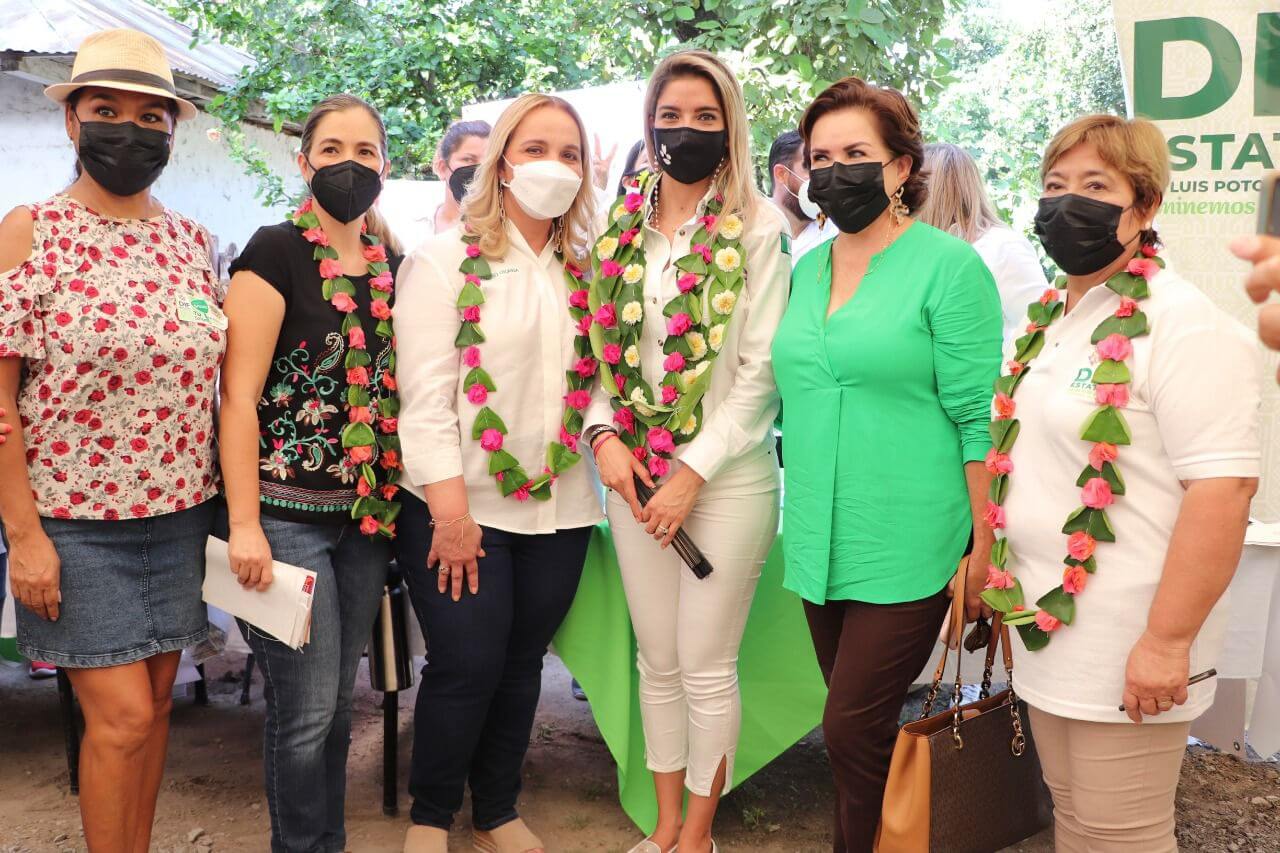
[0,0,253,88]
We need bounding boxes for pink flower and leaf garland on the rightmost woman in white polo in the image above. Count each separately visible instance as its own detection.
[982,246,1165,652]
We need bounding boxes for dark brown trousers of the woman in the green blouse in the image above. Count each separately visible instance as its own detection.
[804,588,951,853]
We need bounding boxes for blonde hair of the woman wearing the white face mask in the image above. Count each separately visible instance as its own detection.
[462,92,595,266]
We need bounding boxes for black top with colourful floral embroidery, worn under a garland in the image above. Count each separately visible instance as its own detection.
[230,222,402,524]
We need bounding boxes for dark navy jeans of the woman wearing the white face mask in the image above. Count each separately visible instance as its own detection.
[396,492,591,830]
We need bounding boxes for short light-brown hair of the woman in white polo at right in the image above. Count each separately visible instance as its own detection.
[1041,114,1169,245]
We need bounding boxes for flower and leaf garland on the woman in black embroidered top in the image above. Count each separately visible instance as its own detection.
[292,199,401,538]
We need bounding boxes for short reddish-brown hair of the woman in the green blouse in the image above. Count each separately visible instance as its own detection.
[800,77,929,213]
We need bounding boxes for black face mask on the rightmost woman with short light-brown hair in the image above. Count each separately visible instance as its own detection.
[1036,193,1125,275]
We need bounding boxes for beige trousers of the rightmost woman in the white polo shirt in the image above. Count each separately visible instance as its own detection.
[1030,708,1192,853]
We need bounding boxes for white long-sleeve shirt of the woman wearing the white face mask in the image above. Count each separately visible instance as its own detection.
[396,224,604,533]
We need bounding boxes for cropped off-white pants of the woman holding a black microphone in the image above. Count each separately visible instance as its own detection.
[608,453,778,797]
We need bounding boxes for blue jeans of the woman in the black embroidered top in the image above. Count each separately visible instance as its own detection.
[230,515,392,853]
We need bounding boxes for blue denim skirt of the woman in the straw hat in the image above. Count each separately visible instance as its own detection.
[17,501,216,669]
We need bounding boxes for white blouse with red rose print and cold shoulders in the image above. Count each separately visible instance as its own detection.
[0,195,227,520]
